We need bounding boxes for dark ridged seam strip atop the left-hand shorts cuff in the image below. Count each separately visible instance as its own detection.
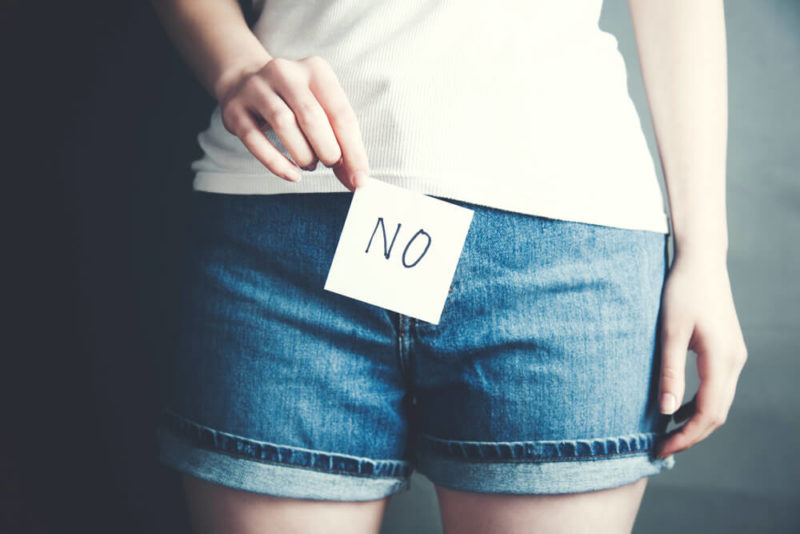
[161,409,411,478]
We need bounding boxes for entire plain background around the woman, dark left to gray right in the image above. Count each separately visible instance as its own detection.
[0,0,800,534]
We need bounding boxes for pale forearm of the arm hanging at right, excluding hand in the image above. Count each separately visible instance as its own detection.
[629,0,728,261]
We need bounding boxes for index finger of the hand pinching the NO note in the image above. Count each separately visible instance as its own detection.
[309,61,369,189]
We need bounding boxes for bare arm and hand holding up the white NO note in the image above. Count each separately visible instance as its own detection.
[151,0,368,191]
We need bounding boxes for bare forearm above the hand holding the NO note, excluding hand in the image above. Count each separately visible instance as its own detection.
[151,0,272,101]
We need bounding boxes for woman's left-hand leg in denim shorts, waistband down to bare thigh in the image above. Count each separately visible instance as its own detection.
[157,192,412,534]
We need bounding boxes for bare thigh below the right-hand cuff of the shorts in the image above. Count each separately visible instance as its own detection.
[436,477,647,534]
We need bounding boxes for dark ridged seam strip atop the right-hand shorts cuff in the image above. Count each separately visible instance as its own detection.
[420,432,658,462]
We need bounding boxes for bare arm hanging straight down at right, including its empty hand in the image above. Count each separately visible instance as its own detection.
[628,0,747,457]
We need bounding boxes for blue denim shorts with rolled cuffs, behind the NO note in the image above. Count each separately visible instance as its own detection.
[156,191,675,501]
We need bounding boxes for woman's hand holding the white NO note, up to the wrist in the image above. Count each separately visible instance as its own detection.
[218,56,368,191]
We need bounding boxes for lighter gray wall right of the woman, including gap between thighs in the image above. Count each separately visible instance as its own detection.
[383,0,800,534]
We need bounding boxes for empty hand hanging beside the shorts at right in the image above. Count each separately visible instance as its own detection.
[658,253,747,458]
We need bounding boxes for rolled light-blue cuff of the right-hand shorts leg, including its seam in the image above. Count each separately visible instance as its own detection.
[417,433,675,494]
